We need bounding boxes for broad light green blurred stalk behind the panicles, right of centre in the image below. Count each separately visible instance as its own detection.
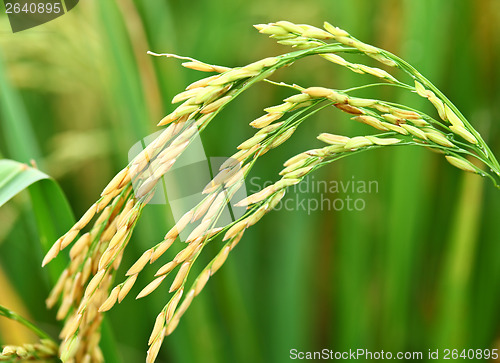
[381,0,452,351]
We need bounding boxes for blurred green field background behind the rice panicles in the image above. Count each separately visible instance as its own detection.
[0,0,500,363]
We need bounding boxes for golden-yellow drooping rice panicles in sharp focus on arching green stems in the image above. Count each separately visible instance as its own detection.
[0,21,500,362]
